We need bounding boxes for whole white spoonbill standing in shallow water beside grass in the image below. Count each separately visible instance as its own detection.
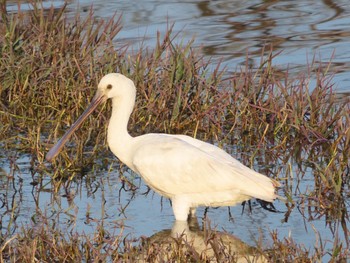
[46,73,279,221]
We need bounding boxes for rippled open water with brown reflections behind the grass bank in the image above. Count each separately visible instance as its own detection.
[70,0,350,92]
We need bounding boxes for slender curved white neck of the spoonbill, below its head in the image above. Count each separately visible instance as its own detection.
[107,98,135,167]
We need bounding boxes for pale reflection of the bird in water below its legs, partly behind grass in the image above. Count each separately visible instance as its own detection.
[141,218,268,263]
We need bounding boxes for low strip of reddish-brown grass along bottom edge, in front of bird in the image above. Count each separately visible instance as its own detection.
[0,222,348,263]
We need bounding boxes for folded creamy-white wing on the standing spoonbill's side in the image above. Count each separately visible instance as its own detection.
[133,134,274,201]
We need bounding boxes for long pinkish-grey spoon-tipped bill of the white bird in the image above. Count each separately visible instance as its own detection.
[46,92,106,162]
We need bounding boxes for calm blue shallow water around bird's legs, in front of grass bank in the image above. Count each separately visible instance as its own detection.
[0,148,349,259]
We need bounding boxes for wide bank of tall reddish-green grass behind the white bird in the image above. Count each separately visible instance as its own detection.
[0,4,349,169]
